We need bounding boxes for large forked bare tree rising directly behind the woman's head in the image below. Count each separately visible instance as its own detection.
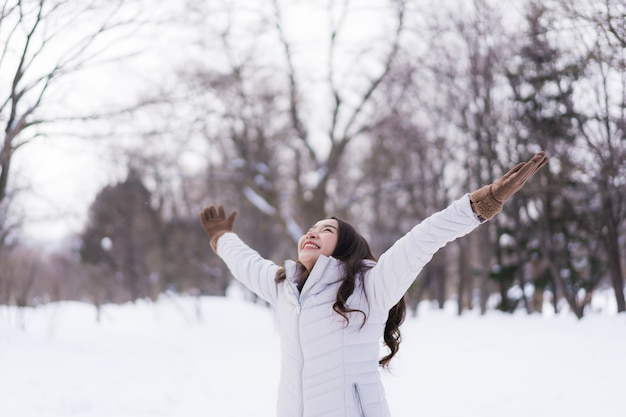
[178,1,404,250]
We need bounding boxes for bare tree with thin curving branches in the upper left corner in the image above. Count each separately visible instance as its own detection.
[0,0,149,242]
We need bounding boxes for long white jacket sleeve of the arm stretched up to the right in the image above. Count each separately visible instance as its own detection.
[365,194,481,310]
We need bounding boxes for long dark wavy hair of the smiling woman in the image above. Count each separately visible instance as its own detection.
[276,217,406,368]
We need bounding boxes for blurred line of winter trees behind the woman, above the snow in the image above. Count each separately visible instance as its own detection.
[0,0,626,317]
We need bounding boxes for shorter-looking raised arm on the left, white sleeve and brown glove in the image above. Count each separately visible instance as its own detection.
[200,205,280,304]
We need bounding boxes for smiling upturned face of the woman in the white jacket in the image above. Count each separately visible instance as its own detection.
[298,219,339,271]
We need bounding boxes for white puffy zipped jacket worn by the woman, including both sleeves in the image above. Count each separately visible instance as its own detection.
[212,195,480,417]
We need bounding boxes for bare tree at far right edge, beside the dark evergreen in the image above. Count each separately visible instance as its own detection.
[559,0,626,312]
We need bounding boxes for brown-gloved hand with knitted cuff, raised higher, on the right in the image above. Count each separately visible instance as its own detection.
[470,151,548,220]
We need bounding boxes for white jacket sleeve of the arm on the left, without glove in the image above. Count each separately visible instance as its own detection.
[217,232,280,305]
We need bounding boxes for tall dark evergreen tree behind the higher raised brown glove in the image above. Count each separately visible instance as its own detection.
[501,2,602,317]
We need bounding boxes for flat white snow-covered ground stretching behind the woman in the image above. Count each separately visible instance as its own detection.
[0,290,626,417]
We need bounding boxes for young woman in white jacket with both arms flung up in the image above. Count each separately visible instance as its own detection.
[200,152,548,417]
